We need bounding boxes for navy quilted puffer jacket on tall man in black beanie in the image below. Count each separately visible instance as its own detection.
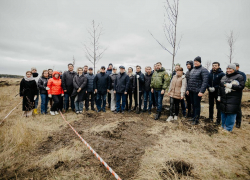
[187,65,209,93]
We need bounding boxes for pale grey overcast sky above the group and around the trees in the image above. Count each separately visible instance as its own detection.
[0,0,250,75]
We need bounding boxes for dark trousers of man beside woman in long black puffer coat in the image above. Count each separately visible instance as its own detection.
[209,90,221,120]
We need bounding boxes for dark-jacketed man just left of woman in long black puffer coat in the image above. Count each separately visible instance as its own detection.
[208,62,225,125]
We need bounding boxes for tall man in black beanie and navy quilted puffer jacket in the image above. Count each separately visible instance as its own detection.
[187,56,209,125]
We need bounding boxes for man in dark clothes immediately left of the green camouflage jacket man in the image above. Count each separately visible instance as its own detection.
[142,66,153,114]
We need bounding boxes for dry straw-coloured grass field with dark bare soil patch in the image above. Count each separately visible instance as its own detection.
[0,79,250,180]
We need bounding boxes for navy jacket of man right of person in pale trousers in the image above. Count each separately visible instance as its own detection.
[114,72,130,93]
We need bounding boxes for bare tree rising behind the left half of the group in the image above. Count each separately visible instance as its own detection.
[84,20,107,74]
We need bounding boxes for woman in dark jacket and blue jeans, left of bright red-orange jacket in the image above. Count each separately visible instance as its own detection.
[38,70,49,114]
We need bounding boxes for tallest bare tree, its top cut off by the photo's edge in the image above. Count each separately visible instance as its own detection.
[149,0,182,72]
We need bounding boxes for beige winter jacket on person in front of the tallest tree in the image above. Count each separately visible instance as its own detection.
[168,75,187,99]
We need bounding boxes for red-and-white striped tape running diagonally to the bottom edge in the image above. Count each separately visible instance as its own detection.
[60,111,121,180]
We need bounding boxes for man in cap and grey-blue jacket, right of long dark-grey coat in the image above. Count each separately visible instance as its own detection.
[85,67,95,111]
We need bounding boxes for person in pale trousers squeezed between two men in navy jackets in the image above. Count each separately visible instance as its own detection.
[109,67,118,112]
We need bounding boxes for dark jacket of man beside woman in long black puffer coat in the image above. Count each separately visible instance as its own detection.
[208,68,225,89]
